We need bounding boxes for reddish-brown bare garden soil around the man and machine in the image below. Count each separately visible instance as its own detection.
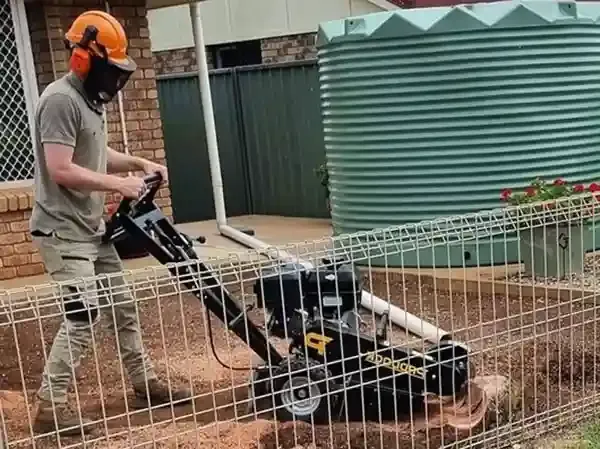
[0,273,598,449]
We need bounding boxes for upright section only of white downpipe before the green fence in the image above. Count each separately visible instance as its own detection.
[190,2,227,230]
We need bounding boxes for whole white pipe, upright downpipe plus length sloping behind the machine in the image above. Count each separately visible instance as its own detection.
[190,2,449,343]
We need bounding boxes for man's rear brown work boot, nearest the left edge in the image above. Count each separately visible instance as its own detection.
[33,400,93,437]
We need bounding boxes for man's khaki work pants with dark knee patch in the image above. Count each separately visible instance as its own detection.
[33,235,156,404]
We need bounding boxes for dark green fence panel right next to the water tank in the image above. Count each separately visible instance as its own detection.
[237,61,329,218]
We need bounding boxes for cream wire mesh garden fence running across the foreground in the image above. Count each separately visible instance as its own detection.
[0,195,600,449]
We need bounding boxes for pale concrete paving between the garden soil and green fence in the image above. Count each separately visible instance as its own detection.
[0,215,332,289]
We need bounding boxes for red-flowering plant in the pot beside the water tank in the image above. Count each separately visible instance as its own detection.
[500,178,600,206]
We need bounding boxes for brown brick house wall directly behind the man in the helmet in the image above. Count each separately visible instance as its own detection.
[0,0,172,280]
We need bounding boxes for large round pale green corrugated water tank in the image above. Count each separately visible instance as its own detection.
[317,0,600,266]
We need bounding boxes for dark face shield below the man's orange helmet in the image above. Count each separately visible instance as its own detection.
[83,56,132,103]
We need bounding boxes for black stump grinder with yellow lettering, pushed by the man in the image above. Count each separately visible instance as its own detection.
[105,175,489,429]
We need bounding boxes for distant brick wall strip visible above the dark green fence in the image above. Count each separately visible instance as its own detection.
[153,33,317,75]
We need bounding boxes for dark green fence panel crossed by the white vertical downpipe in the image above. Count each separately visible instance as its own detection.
[158,73,249,223]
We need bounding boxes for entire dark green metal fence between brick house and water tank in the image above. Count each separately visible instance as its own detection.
[158,61,328,223]
